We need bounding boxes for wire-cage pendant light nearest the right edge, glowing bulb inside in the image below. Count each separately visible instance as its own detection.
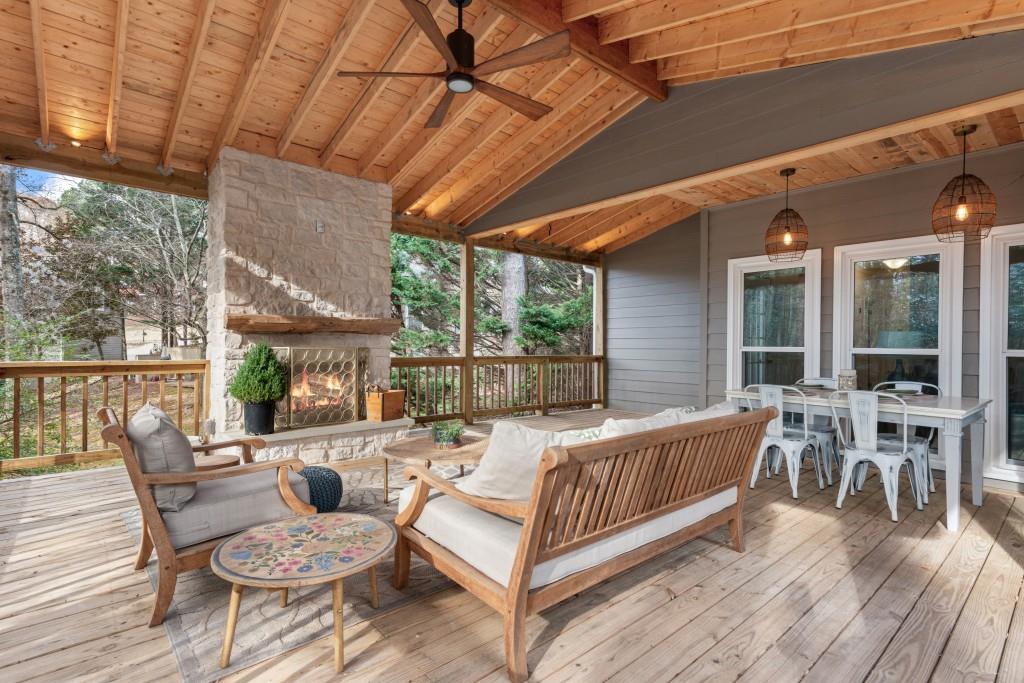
[932,125,995,242]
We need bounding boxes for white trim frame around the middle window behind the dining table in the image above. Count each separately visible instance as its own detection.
[833,234,964,396]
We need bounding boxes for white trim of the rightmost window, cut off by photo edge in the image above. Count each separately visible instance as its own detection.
[978,223,1024,482]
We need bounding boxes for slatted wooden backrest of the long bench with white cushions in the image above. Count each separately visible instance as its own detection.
[537,409,775,563]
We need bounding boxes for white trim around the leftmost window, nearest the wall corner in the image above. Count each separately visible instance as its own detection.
[725,249,821,389]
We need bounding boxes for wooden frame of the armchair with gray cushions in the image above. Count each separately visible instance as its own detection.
[97,407,316,627]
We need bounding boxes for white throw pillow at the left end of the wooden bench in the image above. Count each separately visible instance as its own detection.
[456,420,596,501]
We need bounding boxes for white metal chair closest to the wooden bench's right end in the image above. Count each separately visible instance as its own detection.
[743,384,825,498]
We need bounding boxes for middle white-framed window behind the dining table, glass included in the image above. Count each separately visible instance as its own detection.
[833,236,964,395]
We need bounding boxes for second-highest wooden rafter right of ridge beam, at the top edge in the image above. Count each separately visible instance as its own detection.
[599,0,771,44]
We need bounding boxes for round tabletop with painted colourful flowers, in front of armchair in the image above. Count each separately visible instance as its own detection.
[210,512,396,588]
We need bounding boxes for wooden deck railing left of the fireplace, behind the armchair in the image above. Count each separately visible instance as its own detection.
[0,360,210,471]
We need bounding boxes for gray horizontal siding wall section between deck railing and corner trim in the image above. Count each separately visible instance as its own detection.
[605,216,703,412]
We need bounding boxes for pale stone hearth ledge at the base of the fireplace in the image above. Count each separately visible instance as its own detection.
[232,418,416,465]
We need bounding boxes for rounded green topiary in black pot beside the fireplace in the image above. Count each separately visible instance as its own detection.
[228,342,288,434]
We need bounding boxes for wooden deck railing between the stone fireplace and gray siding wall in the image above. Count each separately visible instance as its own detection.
[391,355,604,422]
